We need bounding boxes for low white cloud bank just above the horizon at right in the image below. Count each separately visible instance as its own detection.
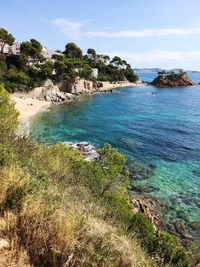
[105,50,200,69]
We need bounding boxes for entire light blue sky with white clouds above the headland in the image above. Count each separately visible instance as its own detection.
[0,0,200,70]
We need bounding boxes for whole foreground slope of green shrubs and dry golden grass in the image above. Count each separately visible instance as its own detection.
[0,86,190,267]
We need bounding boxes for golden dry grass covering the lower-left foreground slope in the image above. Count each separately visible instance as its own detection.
[0,165,151,267]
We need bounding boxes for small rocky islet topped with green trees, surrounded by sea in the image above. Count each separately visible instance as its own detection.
[150,72,195,87]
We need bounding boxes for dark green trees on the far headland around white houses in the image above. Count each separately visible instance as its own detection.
[0,28,138,92]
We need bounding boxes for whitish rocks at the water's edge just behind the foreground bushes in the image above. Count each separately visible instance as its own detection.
[64,142,100,161]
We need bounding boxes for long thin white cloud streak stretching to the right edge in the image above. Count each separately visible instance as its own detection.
[85,27,200,38]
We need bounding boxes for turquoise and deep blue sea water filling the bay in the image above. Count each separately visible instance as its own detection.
[31,74,200,234]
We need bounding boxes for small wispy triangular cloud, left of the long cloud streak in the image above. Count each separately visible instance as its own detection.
[53,19,91,40]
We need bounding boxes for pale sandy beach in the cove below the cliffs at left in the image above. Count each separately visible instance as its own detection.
[10,94,51,122]
